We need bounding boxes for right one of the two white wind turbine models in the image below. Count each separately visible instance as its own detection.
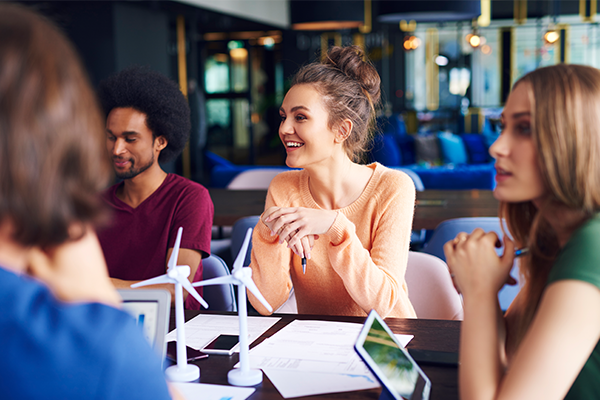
[192,228,273,386]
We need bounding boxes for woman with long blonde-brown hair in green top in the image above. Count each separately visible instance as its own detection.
[444,65,600,400]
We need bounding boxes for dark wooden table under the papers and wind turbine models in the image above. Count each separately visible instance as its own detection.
[171,310,460,400]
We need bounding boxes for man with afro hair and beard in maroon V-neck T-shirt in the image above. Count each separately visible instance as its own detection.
[98,67,214,309]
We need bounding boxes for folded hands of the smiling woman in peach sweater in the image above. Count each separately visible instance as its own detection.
[261,207,338,259]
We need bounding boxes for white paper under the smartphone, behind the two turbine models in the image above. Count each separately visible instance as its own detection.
[166,314,281,352]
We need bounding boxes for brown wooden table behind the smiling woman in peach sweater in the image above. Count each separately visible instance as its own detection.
[209,189,498,230]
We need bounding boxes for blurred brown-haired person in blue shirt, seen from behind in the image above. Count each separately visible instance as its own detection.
[0,3,176,400]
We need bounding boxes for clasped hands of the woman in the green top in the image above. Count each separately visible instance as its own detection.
[444,228,515,296]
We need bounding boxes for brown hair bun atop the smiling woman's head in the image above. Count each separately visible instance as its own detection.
[322,46,381,105]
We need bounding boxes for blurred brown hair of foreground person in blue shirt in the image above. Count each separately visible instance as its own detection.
[0,2,110,248]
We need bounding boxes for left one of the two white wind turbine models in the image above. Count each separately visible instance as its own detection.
[131,227,208,382]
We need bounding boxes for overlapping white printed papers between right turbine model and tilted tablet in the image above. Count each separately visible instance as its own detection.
[244,320,412,398]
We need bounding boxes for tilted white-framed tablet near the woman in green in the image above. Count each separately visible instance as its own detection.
[354,310,431,400]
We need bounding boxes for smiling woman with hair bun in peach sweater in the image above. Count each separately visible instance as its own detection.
[249,46,416,318]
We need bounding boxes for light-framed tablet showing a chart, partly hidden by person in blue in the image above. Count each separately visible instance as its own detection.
[117,289,171,360]
